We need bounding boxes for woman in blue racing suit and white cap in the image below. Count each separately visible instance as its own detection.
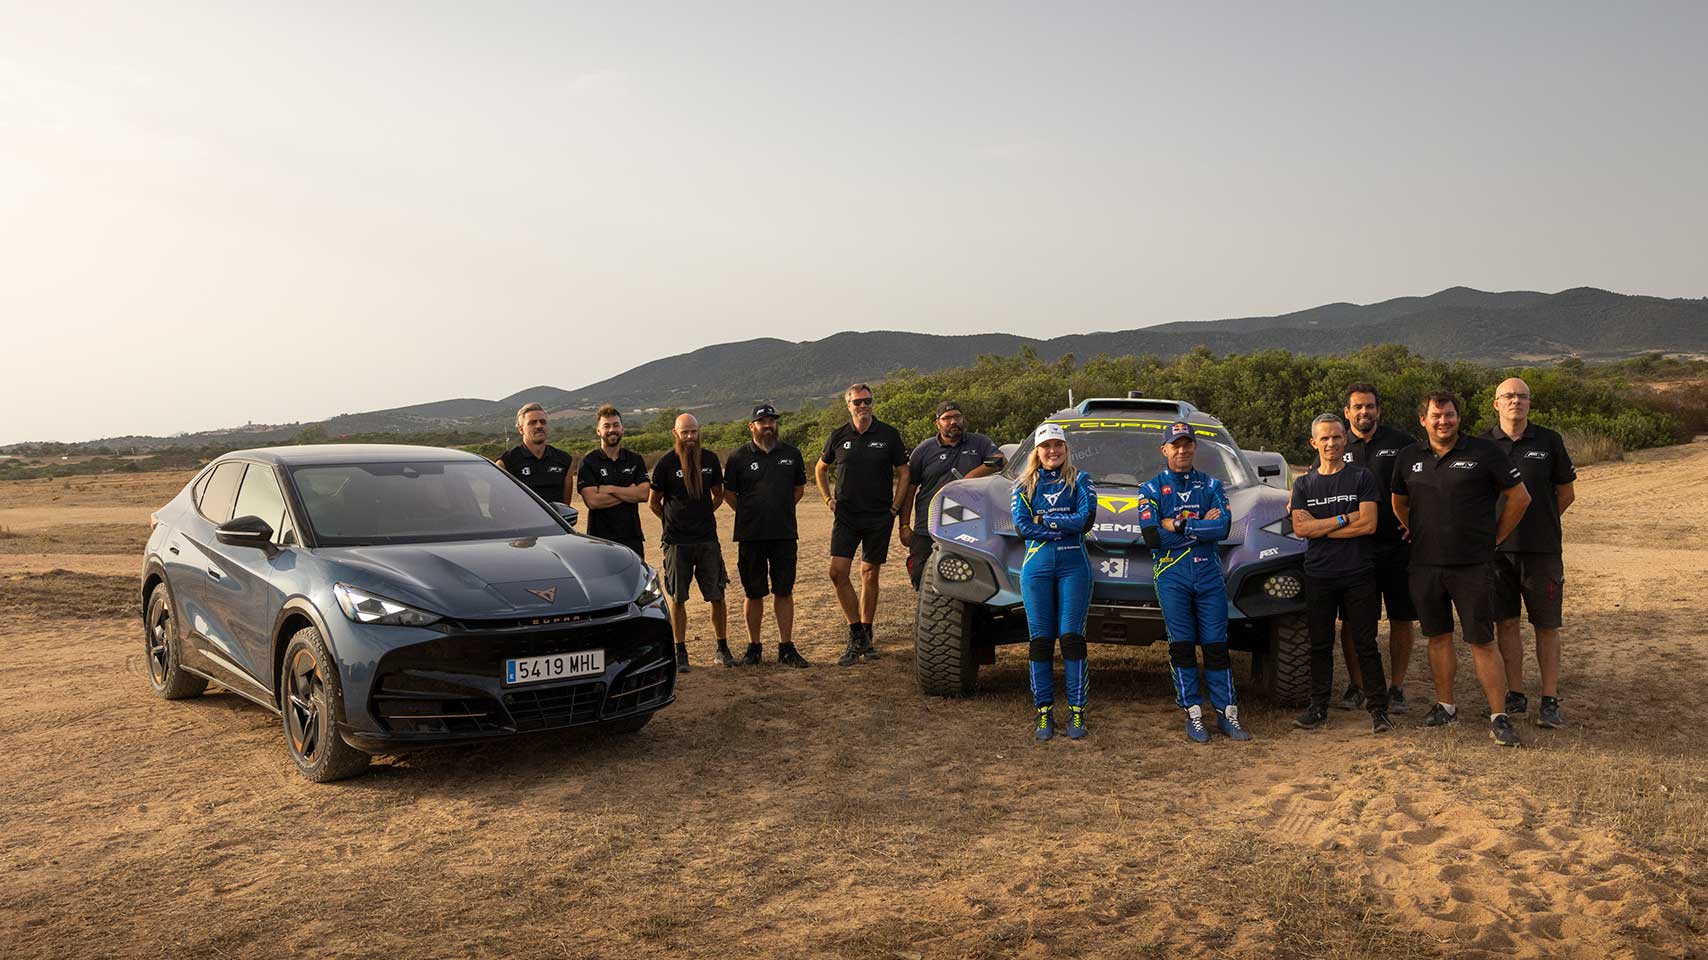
[1011,424,1097,740]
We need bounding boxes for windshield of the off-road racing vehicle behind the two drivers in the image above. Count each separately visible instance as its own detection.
[1004,420,1252,490]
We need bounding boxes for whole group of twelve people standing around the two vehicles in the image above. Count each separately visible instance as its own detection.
[499,378,1576,746]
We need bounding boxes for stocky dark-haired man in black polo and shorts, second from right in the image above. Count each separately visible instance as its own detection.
[1390,389,1530,746]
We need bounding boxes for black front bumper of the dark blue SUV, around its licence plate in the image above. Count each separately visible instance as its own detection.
[333,605,676,753]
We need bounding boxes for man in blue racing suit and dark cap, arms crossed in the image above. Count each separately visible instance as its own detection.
[1139,420,1252,743]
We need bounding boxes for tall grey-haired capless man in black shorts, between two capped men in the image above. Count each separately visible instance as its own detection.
[813,383,907,666]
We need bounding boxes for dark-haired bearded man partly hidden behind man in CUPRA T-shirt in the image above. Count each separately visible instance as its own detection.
[1339,383,1418,714]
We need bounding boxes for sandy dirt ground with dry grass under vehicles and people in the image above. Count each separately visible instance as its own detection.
[0,442,1708,958]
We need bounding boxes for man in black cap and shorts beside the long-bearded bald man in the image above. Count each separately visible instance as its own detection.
[724,403,808,666]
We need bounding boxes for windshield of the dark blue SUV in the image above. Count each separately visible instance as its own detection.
[290,461,564,547]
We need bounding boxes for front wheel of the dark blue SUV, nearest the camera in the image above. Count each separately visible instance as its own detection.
[278,627,371,784]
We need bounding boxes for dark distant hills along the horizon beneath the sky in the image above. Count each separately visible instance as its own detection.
[16,287,1708,448]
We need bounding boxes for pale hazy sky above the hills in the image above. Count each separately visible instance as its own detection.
[0,0,1708,442]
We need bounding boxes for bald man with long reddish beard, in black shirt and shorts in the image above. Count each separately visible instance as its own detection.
[647,413,736,671]
